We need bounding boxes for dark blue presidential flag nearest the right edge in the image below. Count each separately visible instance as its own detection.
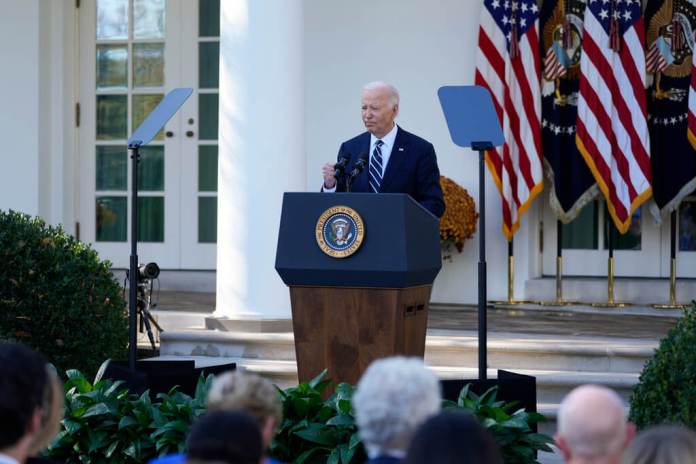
[645,0,696,216]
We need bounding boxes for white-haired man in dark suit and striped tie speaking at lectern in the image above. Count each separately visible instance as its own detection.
[322,82,445,217]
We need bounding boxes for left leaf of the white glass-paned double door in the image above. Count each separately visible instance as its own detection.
[79,0,181,268]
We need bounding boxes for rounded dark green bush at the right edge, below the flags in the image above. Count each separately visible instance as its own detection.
[630,303,696,429]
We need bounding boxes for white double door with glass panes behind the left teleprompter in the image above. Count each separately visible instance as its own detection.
[78,0,219,269]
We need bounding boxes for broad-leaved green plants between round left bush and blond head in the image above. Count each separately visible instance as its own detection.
[47,361,212,464]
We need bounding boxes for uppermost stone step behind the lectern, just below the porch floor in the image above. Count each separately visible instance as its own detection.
[160,329,657,373]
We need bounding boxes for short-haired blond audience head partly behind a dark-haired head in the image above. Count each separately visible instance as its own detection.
[208,371,283,447]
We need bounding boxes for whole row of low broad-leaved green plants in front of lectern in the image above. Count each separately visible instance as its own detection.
[47,364,552,464]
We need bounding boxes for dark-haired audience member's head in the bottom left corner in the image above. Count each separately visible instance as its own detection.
[0,342,47,462]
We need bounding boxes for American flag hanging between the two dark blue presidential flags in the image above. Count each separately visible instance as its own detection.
[576,0,652,233]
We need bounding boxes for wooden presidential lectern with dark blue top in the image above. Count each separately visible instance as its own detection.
[276,193,442,384]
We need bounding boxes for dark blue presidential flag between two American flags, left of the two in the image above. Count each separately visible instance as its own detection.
[540,0,599,224]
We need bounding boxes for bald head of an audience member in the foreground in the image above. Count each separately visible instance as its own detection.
[555,385,635,464]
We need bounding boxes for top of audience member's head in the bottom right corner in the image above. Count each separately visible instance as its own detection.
[623,425,696,464]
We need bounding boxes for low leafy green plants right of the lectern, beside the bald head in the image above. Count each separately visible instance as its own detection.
[443,384,553,464]
